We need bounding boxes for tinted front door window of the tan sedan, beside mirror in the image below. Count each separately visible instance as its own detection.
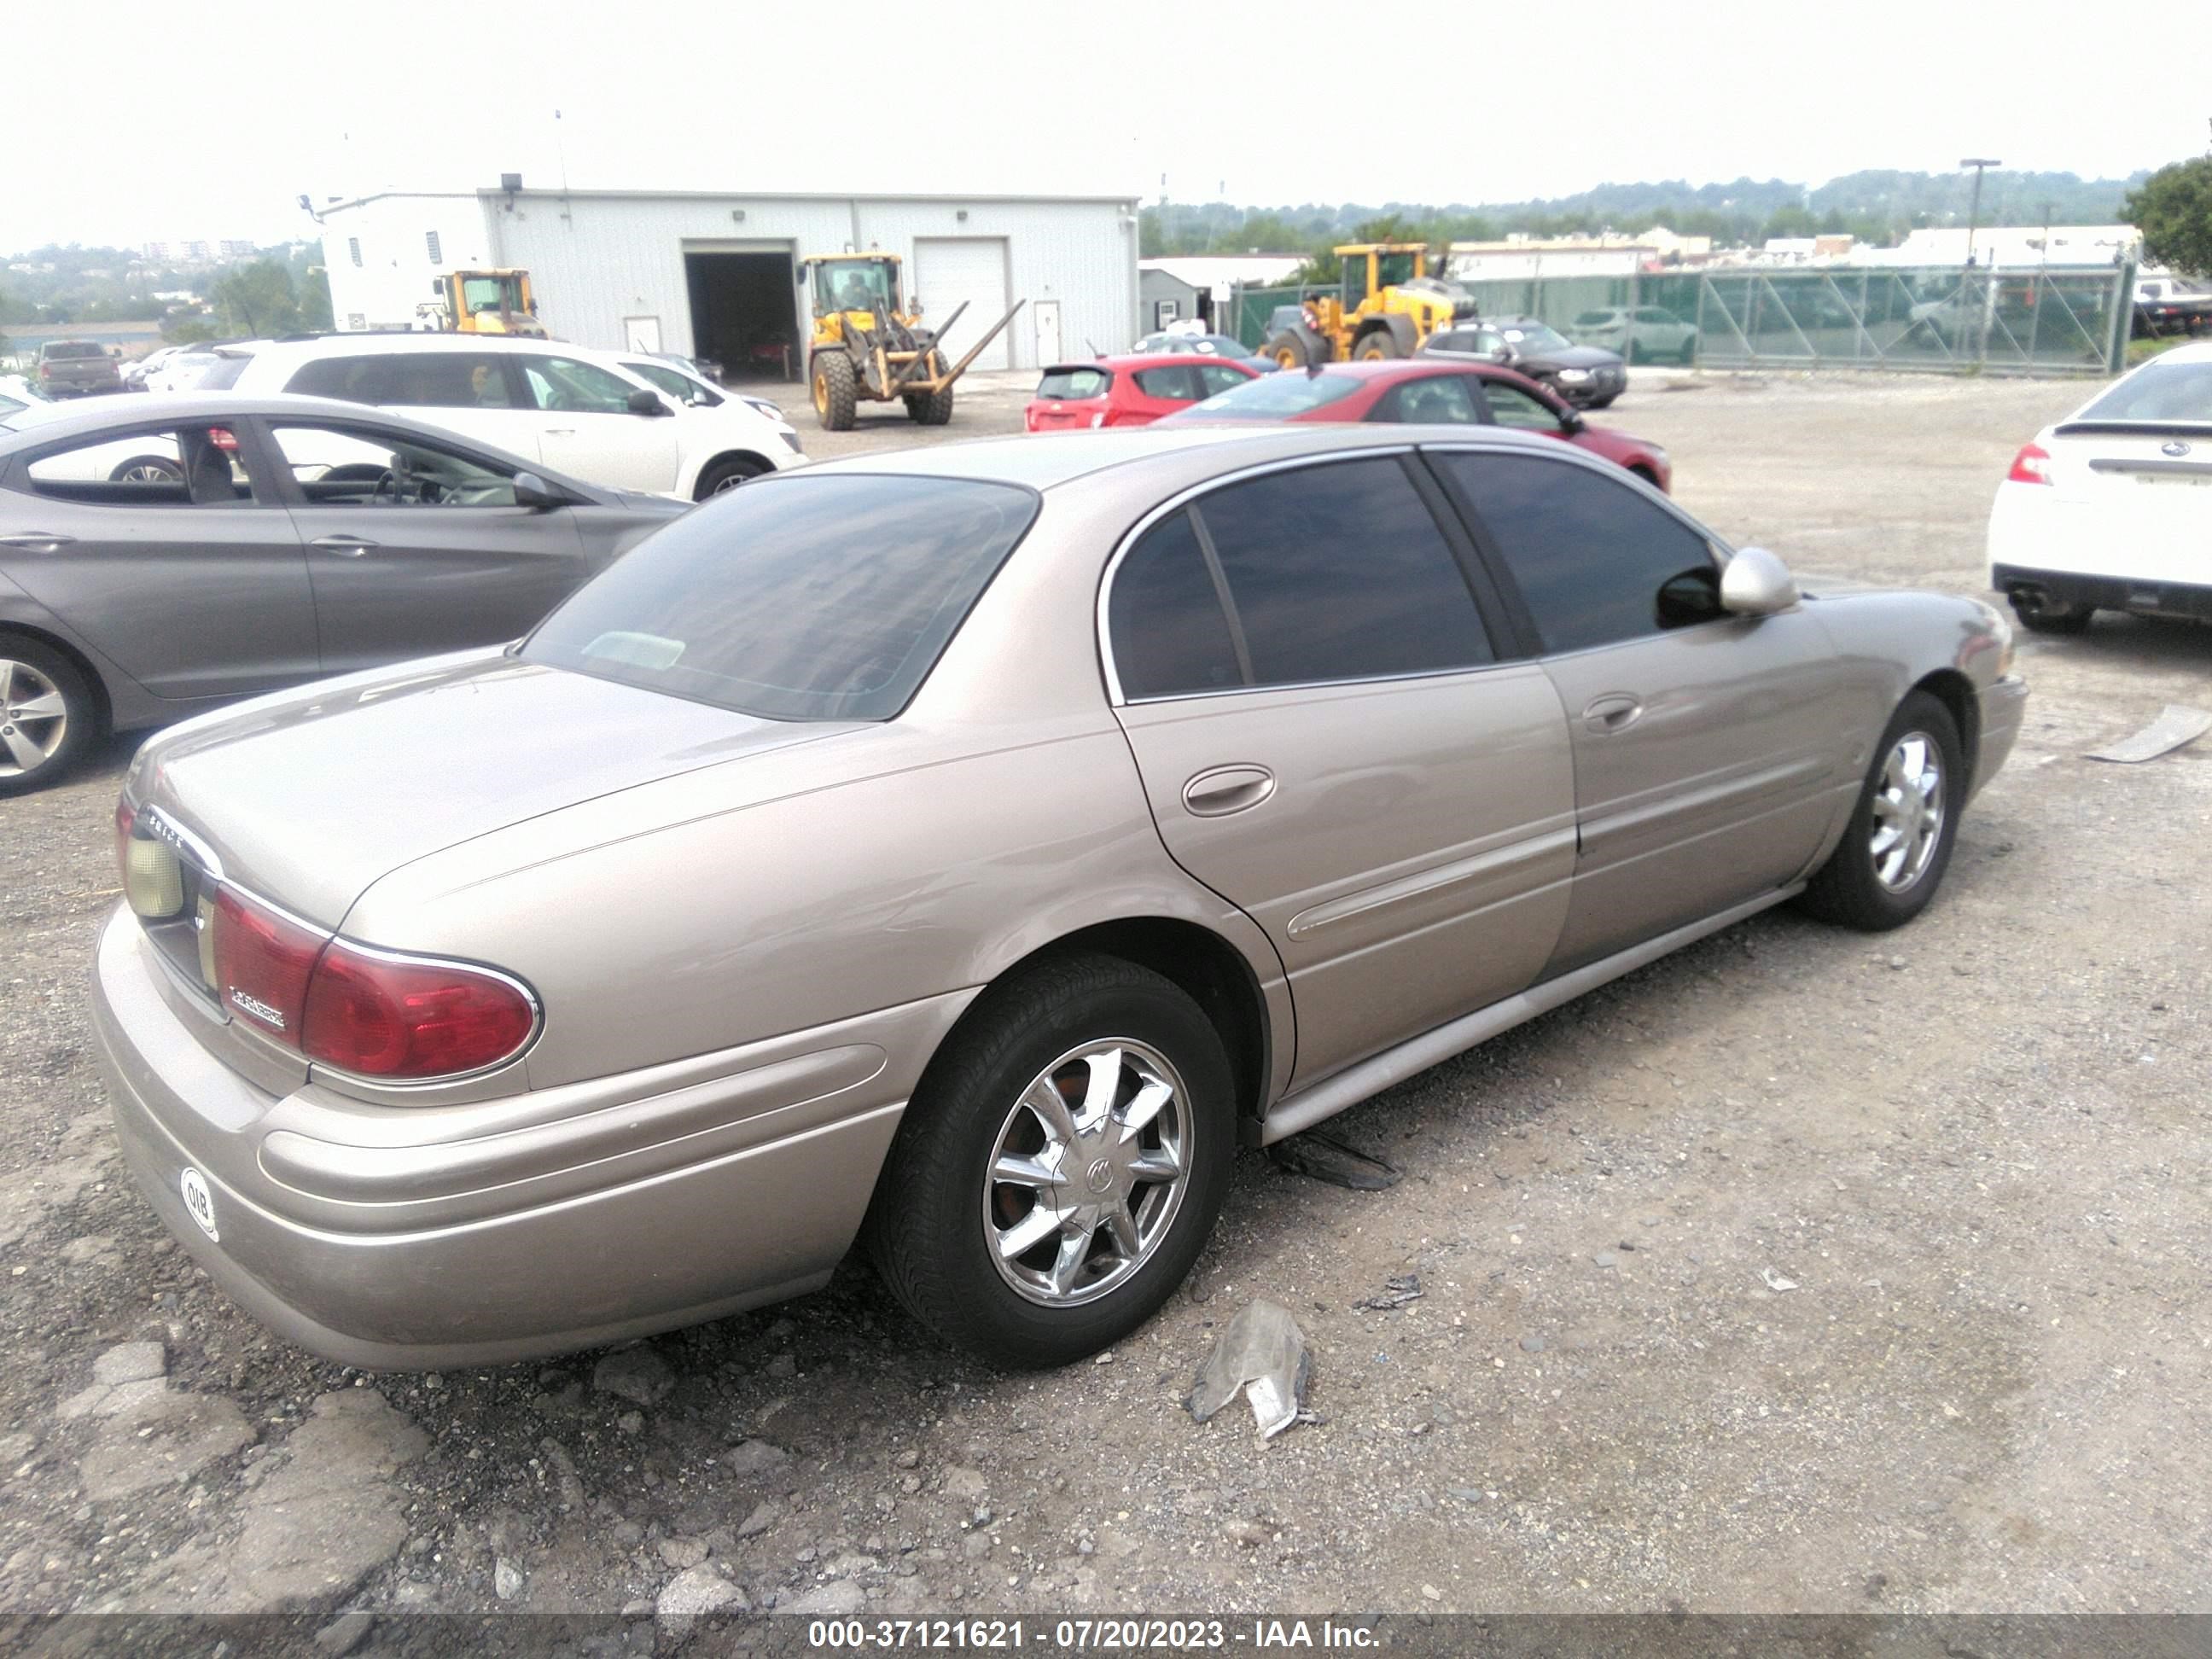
[1438,453,1714,667]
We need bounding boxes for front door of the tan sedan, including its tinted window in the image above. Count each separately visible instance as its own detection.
[1435,451,1867,975]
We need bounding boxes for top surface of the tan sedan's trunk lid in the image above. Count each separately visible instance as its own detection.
[133,653,854,929]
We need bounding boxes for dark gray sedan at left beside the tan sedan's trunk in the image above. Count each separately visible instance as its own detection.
[0,393,686,795]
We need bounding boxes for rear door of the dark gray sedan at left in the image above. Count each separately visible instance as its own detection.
[0,420,321,701]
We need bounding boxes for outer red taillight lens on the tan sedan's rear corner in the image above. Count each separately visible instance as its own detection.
[301,940,538,1081]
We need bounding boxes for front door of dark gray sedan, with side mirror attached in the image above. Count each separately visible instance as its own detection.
[263,420,591,675]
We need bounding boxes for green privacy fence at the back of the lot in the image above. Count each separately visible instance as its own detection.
[1232,265,2134,374]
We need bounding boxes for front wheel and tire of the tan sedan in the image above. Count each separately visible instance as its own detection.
[1798,690,1966,934]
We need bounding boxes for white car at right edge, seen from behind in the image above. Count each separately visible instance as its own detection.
[1988,345,2212,632]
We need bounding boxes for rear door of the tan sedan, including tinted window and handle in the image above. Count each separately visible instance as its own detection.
[1109,451,1575,1084]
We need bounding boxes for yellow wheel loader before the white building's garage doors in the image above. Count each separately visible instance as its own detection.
[799,250,1022,431]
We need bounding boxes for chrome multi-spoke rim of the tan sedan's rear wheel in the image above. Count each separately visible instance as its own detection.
[982,1038,1190,1307]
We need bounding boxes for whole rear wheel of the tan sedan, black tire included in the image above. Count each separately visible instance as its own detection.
[867,956,1237,1367]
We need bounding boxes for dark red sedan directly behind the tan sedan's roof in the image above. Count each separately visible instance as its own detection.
[1167,358,1674,491]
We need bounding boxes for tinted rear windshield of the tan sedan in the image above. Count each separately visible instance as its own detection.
[520,474,1038,721]
